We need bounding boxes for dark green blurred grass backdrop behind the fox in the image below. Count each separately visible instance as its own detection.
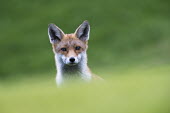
[0,0,170,78]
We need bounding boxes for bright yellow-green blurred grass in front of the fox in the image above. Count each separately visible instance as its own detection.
[0,66,170,113]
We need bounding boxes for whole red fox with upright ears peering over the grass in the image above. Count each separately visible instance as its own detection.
[48,21,100,85]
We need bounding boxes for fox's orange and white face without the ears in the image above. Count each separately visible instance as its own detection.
[53,35,87,66]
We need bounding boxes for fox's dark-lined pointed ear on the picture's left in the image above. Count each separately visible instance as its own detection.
[48,24,64,44]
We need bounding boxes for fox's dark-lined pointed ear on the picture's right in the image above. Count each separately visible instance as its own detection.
[75,20,90,41]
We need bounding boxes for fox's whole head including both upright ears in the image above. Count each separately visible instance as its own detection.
[48,21,90,66]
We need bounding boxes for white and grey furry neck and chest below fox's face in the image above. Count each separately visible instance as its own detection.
[55,52,91,84]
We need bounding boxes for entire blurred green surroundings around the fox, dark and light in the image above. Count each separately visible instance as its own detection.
[0,0,170,113]
